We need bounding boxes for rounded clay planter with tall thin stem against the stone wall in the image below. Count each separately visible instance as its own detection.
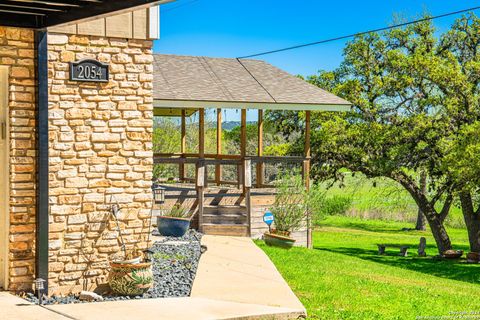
[108,205,153,296]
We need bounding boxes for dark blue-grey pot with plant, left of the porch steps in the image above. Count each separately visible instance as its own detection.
[157,203,191,237]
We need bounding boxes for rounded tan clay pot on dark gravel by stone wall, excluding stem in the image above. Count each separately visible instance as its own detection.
[108,262,153,296]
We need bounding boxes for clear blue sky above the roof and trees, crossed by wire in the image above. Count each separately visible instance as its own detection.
[154,0,480,119]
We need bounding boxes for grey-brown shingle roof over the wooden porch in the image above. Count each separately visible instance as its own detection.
[153,54,351,110]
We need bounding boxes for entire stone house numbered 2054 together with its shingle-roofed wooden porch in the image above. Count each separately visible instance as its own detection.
[0,0,349,294]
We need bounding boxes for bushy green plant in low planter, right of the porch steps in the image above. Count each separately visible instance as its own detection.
[263,176,307,249]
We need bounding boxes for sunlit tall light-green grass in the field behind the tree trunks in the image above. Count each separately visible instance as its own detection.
[325,173,465,228]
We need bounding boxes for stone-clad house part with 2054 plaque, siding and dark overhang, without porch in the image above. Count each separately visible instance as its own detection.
[0,0,171,294]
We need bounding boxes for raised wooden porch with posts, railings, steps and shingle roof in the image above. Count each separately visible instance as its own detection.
[154,55,350,246]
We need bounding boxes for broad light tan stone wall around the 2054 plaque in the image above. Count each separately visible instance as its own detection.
[48,34,153,293]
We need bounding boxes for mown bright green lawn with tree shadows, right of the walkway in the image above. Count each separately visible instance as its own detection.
[258,216,480,319]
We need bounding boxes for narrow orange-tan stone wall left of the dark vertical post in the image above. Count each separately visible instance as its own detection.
[0,27,36,291]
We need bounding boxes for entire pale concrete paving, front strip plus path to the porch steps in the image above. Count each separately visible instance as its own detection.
[0,236,305,320]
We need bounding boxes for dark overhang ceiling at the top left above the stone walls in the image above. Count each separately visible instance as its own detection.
[0,0,171,29]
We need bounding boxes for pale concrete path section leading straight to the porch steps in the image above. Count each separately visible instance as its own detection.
[192,235,305,312]
